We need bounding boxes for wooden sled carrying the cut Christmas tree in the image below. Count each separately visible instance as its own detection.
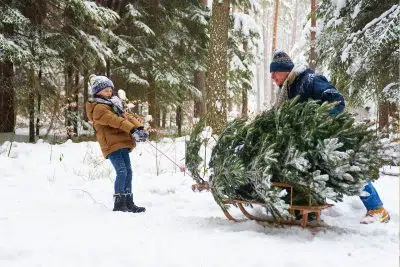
[192,182,333,227]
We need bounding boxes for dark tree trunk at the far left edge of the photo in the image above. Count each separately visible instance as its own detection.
[0,60,15,132]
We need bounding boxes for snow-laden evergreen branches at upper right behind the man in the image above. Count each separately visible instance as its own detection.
[317,0,400,108]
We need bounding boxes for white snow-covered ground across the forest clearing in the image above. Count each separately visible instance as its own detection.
[0,139,399,267]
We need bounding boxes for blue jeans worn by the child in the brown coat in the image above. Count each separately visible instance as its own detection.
[108,148,132,194]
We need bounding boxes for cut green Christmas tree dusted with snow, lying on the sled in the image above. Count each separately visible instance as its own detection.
[188,98,381,219]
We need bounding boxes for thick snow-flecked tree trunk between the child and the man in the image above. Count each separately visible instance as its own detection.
[207,0,230,134]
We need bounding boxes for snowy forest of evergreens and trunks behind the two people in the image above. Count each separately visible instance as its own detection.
[0,0,400,142]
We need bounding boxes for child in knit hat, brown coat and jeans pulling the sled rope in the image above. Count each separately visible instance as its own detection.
[86,75,148,213]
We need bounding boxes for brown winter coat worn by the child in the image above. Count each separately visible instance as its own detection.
[86,102,142,158]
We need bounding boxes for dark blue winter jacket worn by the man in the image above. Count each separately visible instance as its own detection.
[288,69,345,115]
